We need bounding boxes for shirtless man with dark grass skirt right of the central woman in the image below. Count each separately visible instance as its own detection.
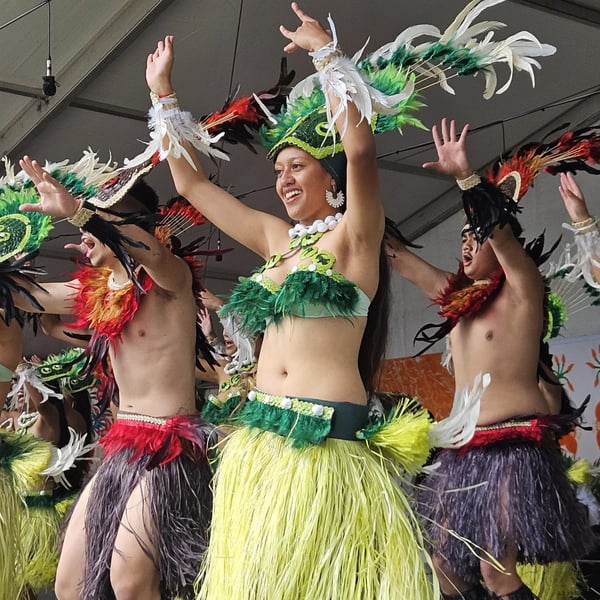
[388,119,590,600]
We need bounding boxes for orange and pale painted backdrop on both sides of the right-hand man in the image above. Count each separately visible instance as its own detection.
[378,336,600,462]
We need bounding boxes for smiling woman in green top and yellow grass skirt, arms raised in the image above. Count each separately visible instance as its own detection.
[146,3,435,600]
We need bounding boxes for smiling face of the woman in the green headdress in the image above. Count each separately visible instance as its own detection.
[275,146,333,225]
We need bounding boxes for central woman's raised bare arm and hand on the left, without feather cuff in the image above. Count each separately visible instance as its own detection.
[146,36,289,258]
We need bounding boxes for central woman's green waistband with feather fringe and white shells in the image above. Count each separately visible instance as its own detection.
[239,390,369,446]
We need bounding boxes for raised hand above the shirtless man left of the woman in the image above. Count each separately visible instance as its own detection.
[19,156,80,217]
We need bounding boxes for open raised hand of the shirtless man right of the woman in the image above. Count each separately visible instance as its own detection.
[423,117,473,179]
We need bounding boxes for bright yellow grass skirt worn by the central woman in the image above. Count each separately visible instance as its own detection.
[197,400,439,600]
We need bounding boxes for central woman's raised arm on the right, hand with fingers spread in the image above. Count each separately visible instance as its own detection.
[280,2,384,245]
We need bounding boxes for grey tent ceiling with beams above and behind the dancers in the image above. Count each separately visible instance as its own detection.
[0,0,600,354]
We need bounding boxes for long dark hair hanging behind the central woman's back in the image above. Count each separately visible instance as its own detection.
[358,241,390,395]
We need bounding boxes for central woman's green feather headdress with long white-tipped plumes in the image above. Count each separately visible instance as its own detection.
[260,0,556,160]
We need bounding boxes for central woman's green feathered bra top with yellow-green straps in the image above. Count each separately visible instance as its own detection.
[220,233,371,335]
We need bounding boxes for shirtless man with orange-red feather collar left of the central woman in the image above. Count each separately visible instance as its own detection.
[11,157,211,600]
